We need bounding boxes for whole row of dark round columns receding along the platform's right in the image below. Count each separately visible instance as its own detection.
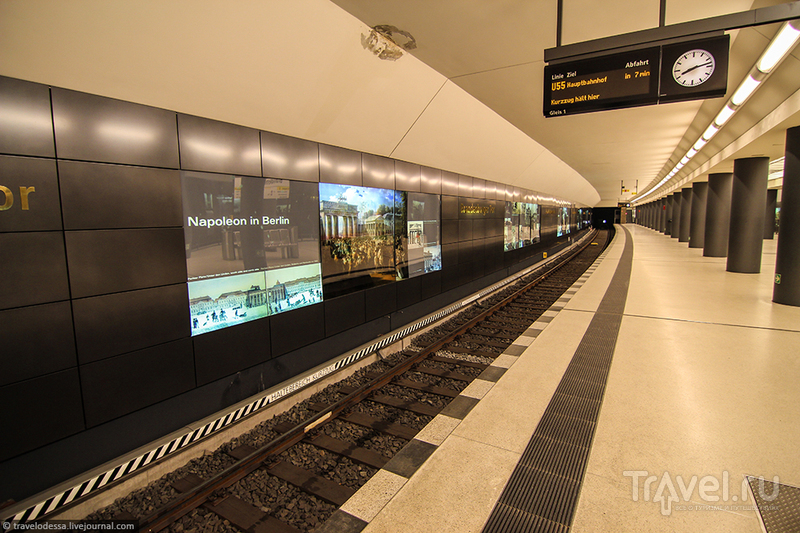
[636,127,800,306]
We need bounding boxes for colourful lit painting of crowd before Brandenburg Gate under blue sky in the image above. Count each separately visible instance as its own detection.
[319,183,405,297]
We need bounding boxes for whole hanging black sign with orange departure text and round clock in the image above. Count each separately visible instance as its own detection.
[543,35,730,117]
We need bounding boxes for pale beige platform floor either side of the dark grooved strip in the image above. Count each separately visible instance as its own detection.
[328,224,800,533]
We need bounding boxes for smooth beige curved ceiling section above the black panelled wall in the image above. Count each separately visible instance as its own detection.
[0,0,600,205]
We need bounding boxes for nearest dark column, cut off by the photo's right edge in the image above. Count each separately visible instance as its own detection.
[772,127,800,307]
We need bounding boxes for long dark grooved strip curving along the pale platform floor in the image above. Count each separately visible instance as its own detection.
[483,227,633,533]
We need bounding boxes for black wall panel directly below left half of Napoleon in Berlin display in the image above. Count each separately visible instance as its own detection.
[192,318,272,386]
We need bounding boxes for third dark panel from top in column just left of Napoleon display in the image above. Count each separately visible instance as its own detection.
[66,228,186,298]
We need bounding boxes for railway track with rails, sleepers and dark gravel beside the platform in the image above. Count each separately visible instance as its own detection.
[87,227,610,533]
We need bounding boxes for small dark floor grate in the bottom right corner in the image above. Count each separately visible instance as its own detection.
[747,476,800,533]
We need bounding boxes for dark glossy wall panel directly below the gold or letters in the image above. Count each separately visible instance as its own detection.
[0,231,69,309]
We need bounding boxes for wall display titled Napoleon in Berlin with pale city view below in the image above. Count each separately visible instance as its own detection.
[182,172,322,335]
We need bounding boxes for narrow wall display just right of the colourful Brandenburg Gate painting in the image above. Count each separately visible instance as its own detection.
[397,192,442,279]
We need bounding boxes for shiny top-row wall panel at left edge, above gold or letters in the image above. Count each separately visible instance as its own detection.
[0,76,55,157]
